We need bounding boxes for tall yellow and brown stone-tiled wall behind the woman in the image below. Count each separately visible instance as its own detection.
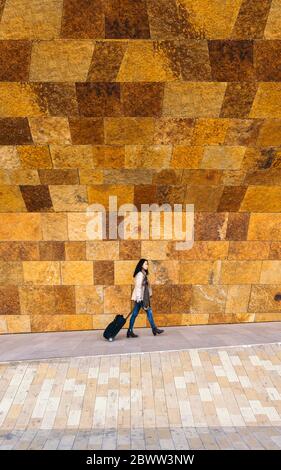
[0,0,281,333]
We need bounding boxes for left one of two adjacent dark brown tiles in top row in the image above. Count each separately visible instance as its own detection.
[61,0,104,39]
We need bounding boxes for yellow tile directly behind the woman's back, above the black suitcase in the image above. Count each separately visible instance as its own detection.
[104,282,131,315]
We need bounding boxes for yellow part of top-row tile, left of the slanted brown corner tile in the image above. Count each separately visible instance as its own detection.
[179,0,242,39]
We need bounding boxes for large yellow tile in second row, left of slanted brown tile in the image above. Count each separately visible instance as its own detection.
[30,39,94,82]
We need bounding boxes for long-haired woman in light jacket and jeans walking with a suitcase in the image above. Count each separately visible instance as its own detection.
[127,258,164,338]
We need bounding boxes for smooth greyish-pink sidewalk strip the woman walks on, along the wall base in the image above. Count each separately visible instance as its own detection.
[0,322,281,362]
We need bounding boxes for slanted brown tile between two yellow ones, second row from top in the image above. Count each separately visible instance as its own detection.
[87,41,127,82]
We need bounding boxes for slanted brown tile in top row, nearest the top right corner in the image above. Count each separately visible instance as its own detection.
[231,0,271,39]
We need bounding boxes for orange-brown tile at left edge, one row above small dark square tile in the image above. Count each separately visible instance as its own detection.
[0,241,39,261]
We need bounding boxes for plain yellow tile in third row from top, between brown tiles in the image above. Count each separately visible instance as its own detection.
[163,82,226,117]
